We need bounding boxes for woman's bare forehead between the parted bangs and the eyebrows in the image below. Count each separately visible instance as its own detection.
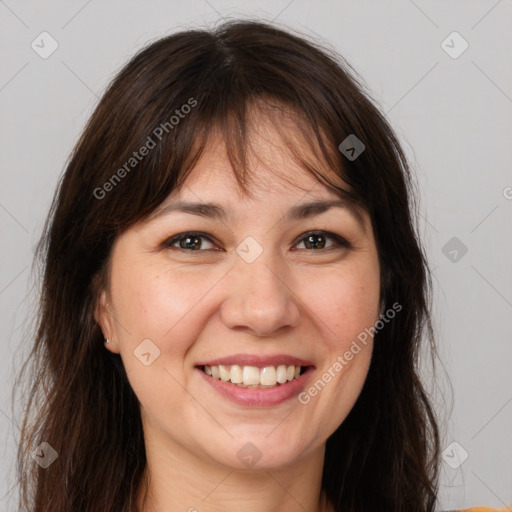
[176,104,349,199]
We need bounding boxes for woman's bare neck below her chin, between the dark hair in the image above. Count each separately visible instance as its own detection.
[137,422,333,512]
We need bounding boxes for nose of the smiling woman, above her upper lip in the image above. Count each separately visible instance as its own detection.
[220,251,301,337]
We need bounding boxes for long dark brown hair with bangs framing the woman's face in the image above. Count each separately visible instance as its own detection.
[17,21,440,512]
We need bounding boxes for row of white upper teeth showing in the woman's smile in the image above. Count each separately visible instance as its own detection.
[203,364,301,386]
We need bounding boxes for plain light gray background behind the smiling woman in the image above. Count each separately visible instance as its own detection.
[0,0,512,511]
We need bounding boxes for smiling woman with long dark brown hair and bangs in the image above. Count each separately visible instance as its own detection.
[14,22,506,512]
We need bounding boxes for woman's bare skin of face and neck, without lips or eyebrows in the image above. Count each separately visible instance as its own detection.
[96,113,380,512]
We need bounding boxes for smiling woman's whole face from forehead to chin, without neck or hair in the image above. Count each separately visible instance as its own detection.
[96,123,379,468]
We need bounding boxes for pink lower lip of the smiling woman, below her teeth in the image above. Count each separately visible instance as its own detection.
[196,366,314,407]
